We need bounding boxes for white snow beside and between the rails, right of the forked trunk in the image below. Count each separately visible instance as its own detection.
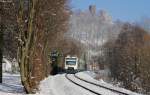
[37,71,142,95]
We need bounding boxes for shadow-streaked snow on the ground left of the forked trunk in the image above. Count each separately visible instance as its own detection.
[0,73,25,95]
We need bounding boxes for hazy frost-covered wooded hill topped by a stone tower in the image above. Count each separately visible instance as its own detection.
[65,6,121,70]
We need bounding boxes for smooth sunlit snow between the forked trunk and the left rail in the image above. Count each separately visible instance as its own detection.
[37,74,95,95]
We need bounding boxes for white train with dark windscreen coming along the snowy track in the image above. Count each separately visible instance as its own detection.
[65,55,78,71]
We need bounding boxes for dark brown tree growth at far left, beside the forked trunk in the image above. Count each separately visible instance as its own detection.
[0,0,18,59]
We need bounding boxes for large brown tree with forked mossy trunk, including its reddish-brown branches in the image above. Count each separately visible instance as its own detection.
[18,0,68,93]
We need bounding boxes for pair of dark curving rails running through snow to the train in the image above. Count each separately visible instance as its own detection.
[65,74,130,95]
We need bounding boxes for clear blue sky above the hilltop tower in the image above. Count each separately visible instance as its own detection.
[70,0,150,22]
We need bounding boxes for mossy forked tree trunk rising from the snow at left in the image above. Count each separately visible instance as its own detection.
[18,0,36,93]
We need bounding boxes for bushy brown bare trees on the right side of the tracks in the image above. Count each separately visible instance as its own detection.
[104,23,150,93]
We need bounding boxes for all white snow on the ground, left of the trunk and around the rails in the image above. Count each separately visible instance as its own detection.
[0,72,143,95]
